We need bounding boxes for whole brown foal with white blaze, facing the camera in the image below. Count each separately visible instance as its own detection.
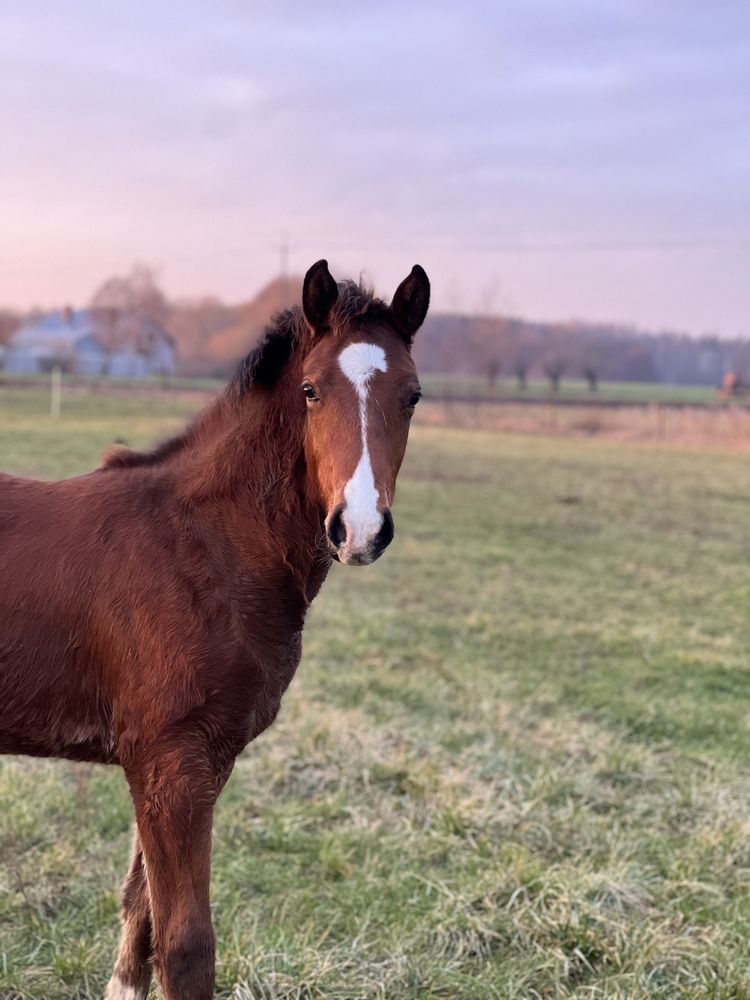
[0,260,430,1000]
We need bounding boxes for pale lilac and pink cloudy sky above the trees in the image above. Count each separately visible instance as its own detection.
[0,0,750,336]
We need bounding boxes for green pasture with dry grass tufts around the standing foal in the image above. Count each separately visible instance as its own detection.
[0,391,750,1000]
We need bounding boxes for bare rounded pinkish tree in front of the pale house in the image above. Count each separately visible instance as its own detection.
[89,264,169,374]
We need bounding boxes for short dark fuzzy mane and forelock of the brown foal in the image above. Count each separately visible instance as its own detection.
[101,281,390,469]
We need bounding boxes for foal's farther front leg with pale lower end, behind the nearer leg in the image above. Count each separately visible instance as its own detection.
[105,829,151,1000]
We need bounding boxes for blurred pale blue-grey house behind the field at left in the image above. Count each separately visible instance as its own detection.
[4,308,176,378]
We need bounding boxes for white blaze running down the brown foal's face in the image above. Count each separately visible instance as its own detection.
[339,344,388,550]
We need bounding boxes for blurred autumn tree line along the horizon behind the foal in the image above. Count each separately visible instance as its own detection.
[0,265,750,391]
